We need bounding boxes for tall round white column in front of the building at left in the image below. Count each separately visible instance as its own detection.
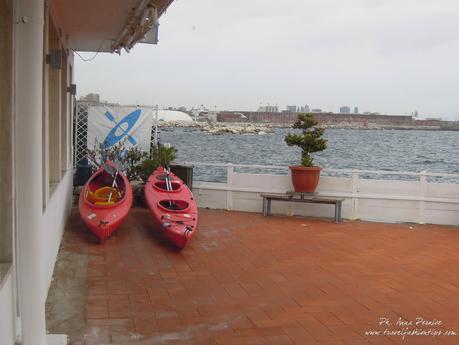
[14,0,46,345]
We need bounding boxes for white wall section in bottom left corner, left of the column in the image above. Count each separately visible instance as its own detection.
[0,273,15,345]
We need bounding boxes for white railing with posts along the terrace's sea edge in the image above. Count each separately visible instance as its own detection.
[179,162,459,223]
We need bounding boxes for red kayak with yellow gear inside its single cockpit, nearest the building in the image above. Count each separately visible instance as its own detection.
[79,162,132,243]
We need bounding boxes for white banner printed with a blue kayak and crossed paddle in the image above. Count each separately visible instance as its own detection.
[87,106,155,151]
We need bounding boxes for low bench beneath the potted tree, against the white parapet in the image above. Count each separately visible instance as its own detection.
[261,192,344,223]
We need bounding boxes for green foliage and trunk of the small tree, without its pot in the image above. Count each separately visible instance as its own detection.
[285,113,327,167]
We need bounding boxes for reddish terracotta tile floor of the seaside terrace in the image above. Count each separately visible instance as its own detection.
[56,208,459,345]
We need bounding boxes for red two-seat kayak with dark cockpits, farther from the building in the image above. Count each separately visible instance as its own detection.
[144,167,198,248]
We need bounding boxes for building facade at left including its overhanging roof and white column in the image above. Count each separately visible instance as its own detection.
[0,0,172,345]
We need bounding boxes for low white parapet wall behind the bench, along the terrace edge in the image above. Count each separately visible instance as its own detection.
[193,172,459,225]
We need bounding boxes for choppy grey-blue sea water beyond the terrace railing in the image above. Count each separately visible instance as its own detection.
[160,128,459,182]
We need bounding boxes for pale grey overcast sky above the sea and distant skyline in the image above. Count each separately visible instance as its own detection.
[75,0,459,119]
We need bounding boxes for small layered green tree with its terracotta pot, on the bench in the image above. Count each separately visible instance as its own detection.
[285,113,327,193]
